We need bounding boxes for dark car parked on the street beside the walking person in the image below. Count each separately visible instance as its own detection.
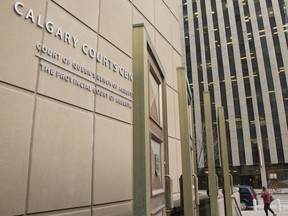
[237,185,258,210]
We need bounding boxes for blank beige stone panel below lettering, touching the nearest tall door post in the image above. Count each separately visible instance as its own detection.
[93,115,133,204]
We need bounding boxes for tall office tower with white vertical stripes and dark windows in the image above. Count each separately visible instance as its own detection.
[182,0,288,187]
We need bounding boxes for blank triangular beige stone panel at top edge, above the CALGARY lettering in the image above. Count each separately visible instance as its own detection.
[54,0,99,32]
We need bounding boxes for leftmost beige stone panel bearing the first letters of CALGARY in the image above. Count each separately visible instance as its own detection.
[0,0,46,91]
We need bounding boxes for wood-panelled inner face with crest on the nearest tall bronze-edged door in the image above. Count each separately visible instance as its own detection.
[148,52,165,216]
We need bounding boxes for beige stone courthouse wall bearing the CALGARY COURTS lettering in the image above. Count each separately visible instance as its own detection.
[0,0,182,216]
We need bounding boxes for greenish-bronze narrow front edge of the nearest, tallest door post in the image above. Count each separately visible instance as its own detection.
[133,24,151,216]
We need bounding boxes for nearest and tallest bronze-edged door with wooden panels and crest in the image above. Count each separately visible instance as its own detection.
[133,25,169,216]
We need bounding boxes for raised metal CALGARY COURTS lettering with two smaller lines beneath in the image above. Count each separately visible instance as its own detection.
[14,2,133,109]
